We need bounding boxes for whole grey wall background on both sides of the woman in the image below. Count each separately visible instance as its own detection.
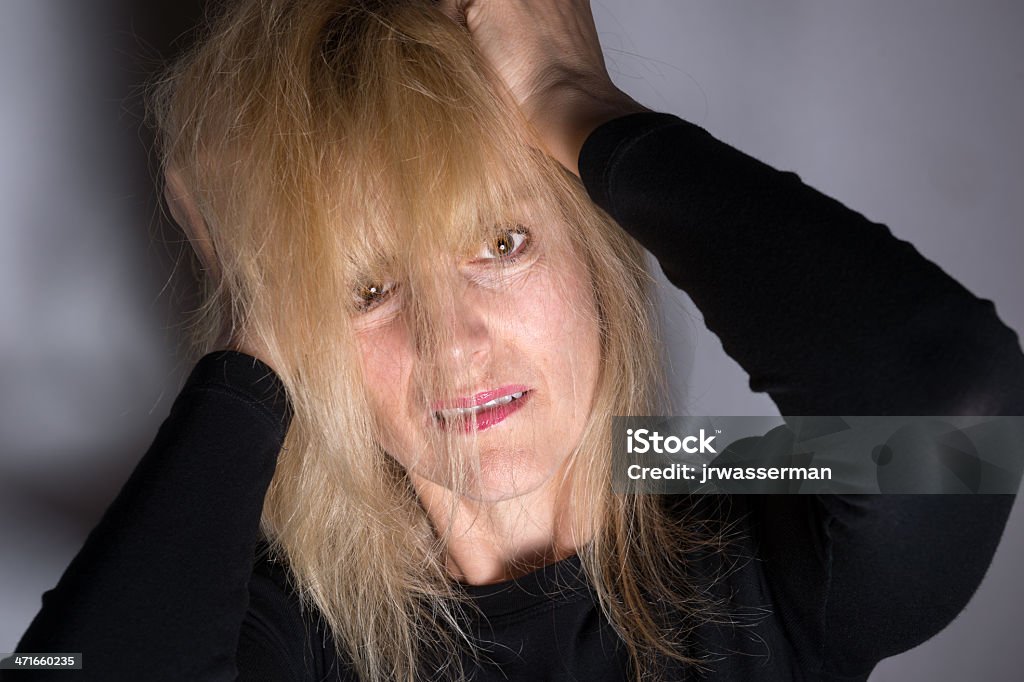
[0,0,1024,682]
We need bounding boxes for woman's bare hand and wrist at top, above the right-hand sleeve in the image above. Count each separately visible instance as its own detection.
[441,0,646,175]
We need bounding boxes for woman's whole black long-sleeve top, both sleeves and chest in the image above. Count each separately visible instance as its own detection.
[11,114,1024,682]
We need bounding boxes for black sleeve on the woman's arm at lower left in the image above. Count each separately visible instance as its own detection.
[10,351,290,681]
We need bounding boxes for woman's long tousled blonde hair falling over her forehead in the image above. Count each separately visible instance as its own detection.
[153,0,718,682]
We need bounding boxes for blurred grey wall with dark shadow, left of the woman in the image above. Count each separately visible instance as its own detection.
[0,0,216,651]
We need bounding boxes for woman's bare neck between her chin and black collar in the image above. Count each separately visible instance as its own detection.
[411,466,586,585]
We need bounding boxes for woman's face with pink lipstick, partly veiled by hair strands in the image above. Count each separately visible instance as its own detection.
[354,211,600,501]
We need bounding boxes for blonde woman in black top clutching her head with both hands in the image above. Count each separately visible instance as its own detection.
[9,0,1024,680]
